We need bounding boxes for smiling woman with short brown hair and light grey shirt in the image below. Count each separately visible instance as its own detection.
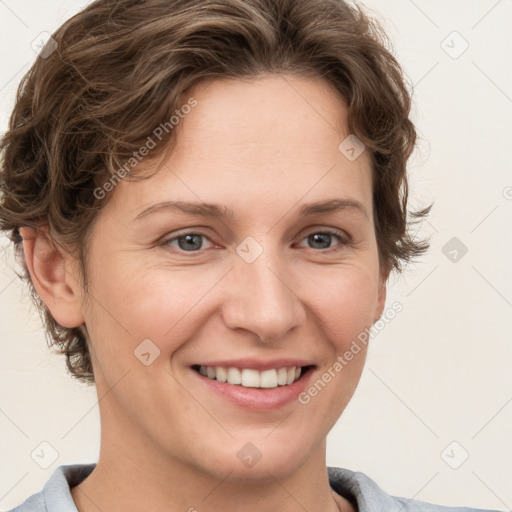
[0,0,502,512]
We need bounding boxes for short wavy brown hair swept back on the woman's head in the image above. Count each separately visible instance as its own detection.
[0,0,432,383]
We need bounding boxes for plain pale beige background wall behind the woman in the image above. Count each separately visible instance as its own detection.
[0,0,512,510]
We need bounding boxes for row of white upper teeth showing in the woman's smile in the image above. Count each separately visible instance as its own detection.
[199,366,301,388]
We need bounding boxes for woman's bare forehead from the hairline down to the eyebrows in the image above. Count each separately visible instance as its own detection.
[109,75,371,220]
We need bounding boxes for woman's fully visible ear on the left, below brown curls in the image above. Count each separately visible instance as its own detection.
[20,226,84,328]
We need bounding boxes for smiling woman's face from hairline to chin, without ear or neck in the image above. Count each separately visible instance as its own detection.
[78,75,385,478]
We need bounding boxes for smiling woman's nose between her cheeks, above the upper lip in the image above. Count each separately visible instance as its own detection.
[222,241,306,343]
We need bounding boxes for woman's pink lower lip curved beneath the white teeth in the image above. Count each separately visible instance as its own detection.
[191,367,314,411]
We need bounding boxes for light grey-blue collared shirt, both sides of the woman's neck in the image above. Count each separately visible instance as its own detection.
[3,464,498,512]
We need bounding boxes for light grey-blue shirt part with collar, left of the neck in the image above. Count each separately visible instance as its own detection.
[7,464,96,512]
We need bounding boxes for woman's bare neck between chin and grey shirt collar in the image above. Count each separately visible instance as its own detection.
[71,414,354,512]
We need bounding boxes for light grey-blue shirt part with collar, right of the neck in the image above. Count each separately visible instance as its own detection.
[327,467,499,512]
